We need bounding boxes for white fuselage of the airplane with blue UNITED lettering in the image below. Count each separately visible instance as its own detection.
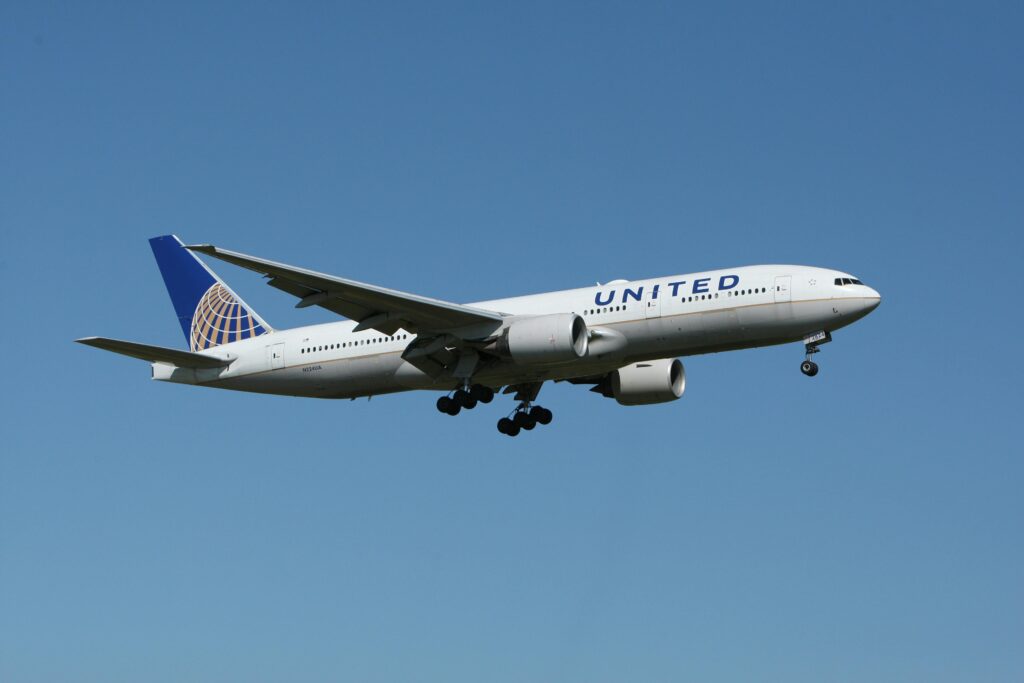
[154,265,881,398]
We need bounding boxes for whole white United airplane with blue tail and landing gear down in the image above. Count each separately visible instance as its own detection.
[76,234,882,436]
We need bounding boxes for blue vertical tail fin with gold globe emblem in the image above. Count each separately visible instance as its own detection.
[150,234,272,351]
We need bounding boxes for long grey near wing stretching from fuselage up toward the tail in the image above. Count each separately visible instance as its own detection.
[187,245,502,335]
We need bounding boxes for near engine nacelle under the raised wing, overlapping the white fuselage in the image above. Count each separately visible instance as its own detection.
[498,313,588,366]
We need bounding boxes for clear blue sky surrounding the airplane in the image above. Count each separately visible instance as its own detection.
[0,2,1024,682]
